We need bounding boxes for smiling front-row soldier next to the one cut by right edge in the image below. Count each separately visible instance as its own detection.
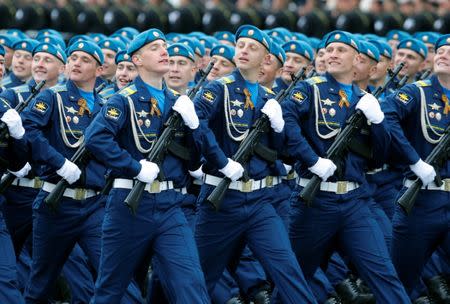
[283,31,409,303]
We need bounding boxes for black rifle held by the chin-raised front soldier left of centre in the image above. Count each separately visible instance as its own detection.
[125,62,214,214]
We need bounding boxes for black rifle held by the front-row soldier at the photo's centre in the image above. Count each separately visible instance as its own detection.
[206,68,306,211]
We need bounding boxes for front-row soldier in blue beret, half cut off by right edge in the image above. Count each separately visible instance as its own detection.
[386,34,450,303]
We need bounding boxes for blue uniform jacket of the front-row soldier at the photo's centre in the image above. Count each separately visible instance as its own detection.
[193,70,286,179]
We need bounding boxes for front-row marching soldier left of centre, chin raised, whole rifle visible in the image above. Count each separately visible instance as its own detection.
[86,29,210,304]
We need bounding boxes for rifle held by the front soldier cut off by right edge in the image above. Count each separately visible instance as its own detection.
[397,125,450,214]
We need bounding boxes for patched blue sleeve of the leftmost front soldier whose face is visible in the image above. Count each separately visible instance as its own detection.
[22,90,65,170]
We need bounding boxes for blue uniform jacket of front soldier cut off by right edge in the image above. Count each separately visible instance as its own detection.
[384,75,450,178]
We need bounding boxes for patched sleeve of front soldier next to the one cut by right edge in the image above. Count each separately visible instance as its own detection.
[282,83,319,167]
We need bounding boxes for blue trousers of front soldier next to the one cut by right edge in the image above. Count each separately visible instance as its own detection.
[289,187,409,303]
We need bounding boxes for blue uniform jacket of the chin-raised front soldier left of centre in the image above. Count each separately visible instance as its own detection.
[86,77,192,188]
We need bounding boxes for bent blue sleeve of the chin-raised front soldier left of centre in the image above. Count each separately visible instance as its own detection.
[85,95,141,178]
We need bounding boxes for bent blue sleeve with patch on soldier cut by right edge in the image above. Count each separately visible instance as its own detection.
[382,85,420,165]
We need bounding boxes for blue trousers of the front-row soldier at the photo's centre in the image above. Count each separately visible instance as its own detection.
[195,185,316,304]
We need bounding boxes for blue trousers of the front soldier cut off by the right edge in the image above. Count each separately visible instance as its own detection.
[391,189,450,295]
